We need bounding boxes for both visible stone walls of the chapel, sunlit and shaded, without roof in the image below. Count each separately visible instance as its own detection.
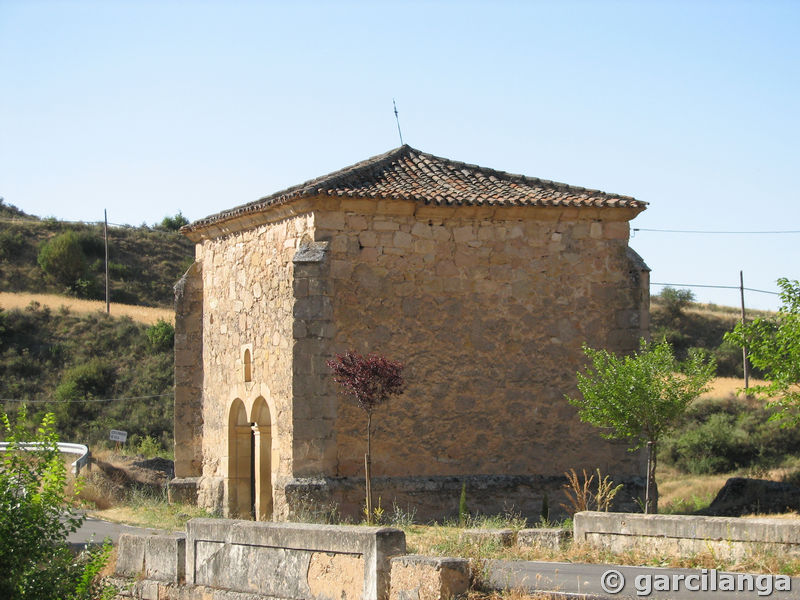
[184,198,649,519]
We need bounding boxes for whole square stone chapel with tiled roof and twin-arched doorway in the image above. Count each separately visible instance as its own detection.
[170,145,649,520]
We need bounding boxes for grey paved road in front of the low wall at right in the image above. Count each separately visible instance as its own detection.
[488,560,800,600]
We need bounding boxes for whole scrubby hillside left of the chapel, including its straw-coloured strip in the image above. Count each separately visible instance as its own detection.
[0,200,183,450]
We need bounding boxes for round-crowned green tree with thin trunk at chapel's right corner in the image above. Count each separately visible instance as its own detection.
[568,340,715,513]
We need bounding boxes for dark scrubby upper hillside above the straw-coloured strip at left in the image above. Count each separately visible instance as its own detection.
[0,200,194,307]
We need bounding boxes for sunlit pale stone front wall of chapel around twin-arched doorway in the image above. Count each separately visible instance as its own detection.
[197,214,312,510]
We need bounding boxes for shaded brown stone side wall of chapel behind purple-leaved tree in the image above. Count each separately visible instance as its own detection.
[314,200,647,477]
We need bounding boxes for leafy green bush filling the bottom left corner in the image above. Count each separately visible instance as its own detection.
[0,409,113,600]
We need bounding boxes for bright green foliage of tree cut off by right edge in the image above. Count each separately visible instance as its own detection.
[725,278,800,425]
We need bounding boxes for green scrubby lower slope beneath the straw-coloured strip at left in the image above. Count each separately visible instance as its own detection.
[0,305,174,449]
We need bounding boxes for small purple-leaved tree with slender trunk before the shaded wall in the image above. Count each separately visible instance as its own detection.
[327,351,405,524]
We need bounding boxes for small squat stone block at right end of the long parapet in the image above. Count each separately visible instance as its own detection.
[389,554,470,600]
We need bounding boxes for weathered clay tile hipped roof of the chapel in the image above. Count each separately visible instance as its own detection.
[183,145,647,233]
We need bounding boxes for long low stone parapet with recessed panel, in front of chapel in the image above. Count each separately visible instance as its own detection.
[186,519,406,600]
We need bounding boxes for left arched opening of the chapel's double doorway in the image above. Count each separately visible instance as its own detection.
[227,398,254,519]
